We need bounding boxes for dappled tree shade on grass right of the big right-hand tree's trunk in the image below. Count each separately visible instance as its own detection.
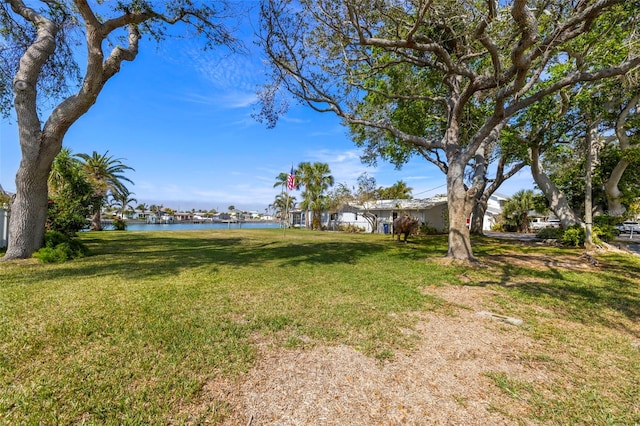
[469,254,640,336]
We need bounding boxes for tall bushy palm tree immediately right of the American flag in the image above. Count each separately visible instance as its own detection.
[296,162,334,229]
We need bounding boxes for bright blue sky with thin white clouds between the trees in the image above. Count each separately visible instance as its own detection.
[0,10,532,212]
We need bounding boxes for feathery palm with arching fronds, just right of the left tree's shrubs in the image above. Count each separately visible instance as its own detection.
[76,151,134,231]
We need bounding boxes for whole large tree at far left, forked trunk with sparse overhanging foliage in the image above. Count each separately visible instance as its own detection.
[0,0,238,260]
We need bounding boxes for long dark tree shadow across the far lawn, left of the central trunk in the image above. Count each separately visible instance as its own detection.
[28,232,387,279]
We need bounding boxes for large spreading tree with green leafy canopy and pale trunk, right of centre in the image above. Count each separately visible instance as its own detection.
[261,0,640,261]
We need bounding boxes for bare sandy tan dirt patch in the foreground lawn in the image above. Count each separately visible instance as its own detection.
[182,286,550,425]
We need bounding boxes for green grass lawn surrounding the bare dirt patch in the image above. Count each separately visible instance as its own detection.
[0,230,640,425]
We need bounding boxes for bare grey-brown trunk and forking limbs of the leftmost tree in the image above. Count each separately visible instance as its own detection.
[2,0,144,260]
